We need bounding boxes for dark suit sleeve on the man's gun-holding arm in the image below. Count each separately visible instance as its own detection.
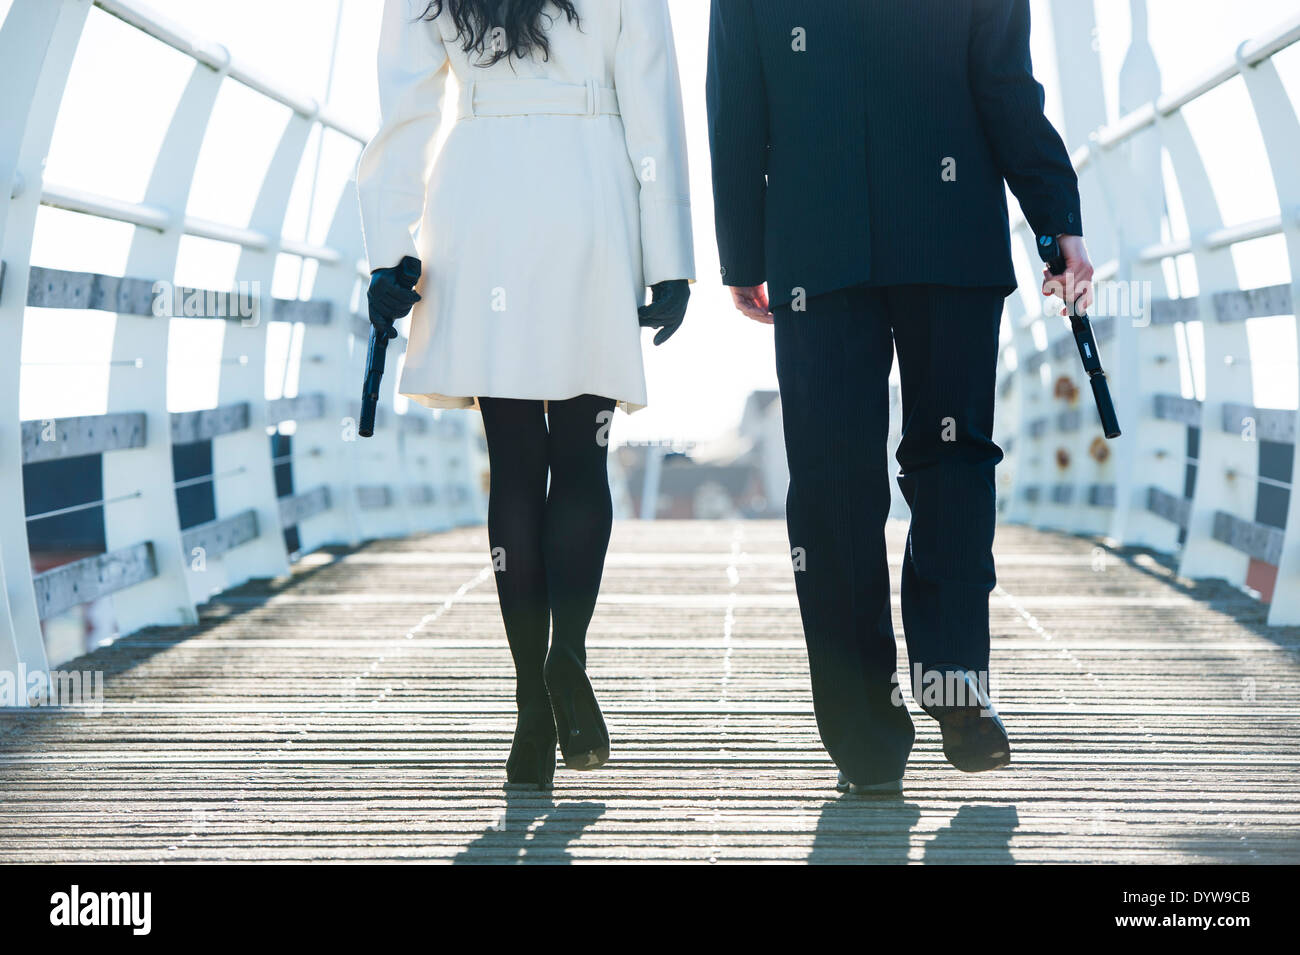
[970,0,1083,235]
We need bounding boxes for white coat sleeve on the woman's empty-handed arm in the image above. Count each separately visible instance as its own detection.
[614,0,696,286]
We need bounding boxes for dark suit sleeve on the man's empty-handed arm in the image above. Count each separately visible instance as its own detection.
[706,0,768,287]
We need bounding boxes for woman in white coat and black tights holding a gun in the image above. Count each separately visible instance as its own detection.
[358,0,694,789]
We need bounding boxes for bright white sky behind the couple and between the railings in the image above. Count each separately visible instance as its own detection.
[10,0,1300,440]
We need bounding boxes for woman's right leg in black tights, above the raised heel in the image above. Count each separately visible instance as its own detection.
[542,395,614,664]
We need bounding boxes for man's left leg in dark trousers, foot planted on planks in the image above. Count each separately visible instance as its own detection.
[775,283,913,785]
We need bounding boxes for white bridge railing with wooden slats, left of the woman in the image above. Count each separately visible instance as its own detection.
[0,0,482,702]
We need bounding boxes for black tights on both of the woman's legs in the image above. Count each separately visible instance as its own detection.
[478,395,614,711]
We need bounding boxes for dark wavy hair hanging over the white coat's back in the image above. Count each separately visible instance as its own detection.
[420,0,581,66]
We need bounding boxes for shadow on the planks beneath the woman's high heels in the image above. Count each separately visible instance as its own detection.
[452,793,606,865]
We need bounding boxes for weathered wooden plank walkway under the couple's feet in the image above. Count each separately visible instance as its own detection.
[0,522,1300,863]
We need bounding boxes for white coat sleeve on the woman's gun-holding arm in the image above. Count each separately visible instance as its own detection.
[356,0,449,270]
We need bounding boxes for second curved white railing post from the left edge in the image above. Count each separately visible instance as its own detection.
[104,55,225,633]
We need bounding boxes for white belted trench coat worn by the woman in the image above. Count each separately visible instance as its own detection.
[356,0,696,412]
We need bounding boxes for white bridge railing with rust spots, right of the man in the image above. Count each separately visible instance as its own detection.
[1000,18,1300,624]
